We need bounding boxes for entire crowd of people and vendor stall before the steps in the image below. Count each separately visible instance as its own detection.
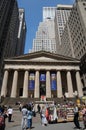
[0,102,86,130]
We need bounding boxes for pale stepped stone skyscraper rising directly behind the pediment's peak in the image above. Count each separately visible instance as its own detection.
[32,19,56,53]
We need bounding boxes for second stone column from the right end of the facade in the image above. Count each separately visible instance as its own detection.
[67,71,73,97]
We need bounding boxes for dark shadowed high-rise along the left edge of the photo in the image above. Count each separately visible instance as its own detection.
[0,0,26,86]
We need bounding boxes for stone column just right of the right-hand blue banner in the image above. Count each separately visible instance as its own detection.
[57,71,63,98]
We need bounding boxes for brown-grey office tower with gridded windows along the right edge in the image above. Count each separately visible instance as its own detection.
[55,0,86,87]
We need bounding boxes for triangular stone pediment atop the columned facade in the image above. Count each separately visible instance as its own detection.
[6,51,79,62]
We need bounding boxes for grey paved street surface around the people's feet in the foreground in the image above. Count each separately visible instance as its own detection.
[6,111,83,130]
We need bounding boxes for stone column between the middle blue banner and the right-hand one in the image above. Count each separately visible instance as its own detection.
[46,71,51,98]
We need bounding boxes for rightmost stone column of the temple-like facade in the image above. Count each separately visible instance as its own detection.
[76,71,83,97]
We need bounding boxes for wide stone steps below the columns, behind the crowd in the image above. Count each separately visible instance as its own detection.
[1,97,75,110]
